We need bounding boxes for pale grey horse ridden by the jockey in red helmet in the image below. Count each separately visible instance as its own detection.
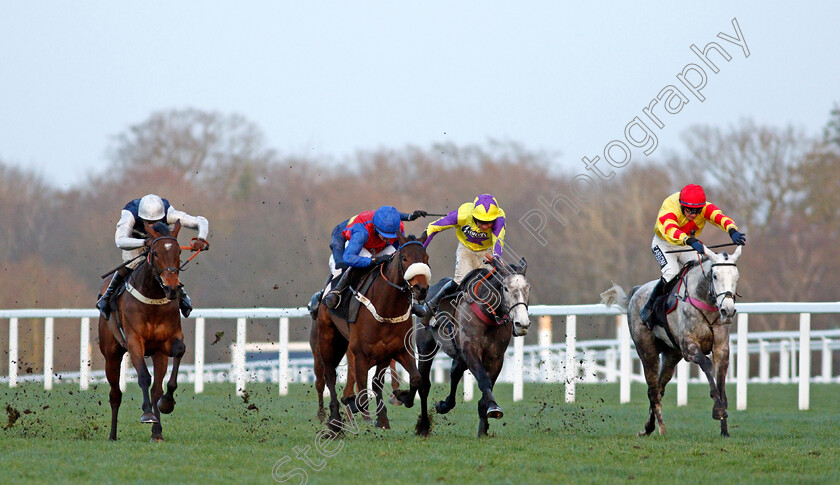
[601,246,742,436]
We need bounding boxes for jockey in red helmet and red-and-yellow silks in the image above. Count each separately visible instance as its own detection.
[641,184,747,327]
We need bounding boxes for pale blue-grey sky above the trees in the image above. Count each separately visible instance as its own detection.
[0,0,840,188]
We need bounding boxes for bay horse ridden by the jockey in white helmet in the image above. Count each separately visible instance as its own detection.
[99,221,187,442]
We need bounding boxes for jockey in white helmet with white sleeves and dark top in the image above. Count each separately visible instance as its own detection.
[96,194,210,320]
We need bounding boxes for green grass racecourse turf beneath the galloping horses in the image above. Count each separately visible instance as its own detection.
[0,384,840,484]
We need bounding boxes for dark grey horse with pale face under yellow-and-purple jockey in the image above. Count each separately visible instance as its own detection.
[415,258,531,438]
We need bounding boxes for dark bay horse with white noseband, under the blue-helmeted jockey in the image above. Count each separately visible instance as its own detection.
[310,234,431,433]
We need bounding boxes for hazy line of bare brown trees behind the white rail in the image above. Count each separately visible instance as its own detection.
[0,106,840,370]
